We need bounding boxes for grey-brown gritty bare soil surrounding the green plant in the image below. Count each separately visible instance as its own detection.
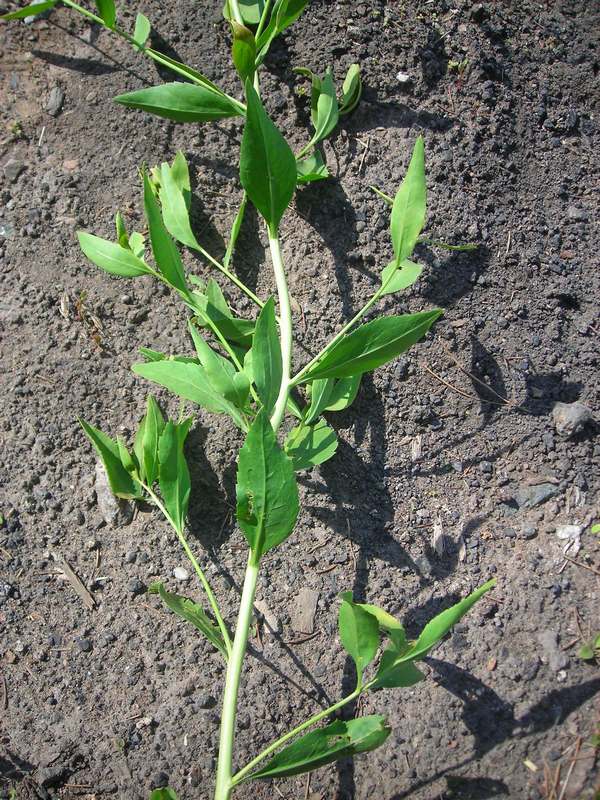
[0,0,600,800]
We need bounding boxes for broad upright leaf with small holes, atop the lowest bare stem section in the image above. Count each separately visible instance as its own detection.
[236,410,299,559]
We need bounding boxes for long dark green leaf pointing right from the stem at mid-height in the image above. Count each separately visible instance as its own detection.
[302,308,443,383]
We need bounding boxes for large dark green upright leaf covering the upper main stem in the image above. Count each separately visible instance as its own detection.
[240,80,296,235]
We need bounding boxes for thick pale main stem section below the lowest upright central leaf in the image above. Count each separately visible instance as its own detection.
[214,552,259,800]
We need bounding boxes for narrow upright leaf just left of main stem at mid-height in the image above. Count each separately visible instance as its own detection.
[252,297,283,415]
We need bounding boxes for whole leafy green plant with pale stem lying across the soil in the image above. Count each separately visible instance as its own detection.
[2,0,494,800]
